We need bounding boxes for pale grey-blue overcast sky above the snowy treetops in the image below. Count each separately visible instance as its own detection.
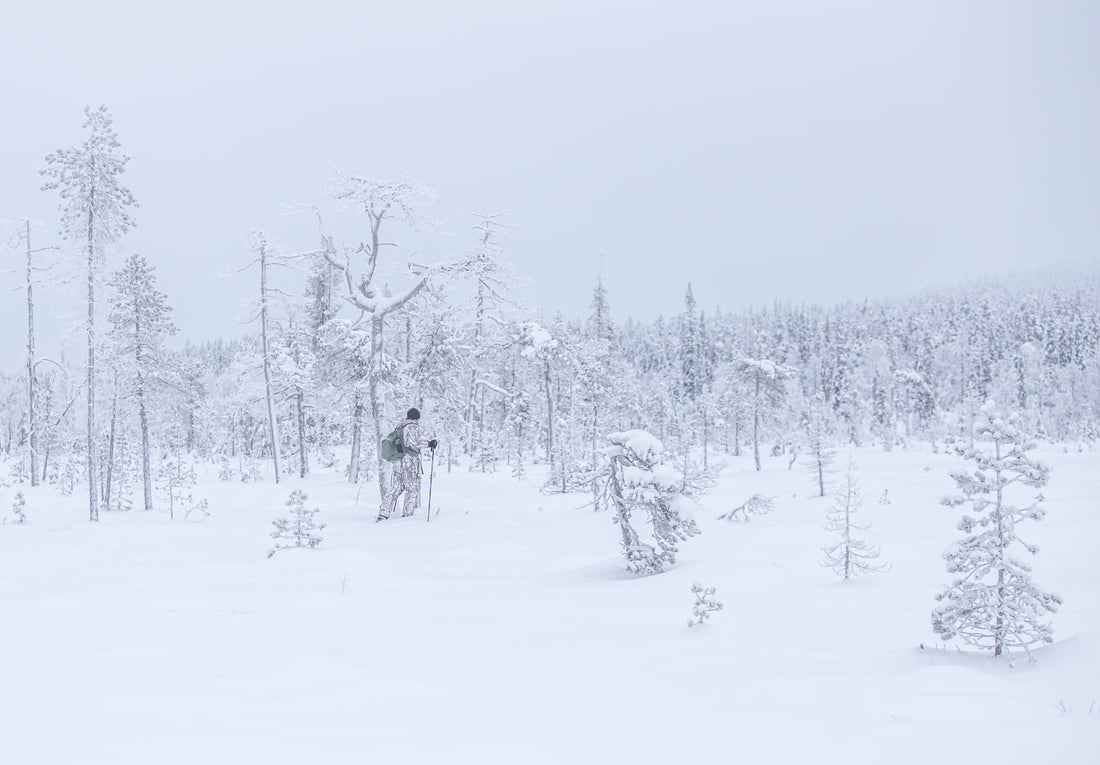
[0,0,1100,358]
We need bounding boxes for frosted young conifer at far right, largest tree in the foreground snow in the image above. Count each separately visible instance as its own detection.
[932,402,1062,656]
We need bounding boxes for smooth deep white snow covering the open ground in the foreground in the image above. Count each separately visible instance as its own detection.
[0,445,1100,765]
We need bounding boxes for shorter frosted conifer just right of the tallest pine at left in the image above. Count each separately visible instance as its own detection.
[109,254,177,510]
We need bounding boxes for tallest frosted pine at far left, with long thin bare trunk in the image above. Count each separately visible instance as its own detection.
[40,106,136,521]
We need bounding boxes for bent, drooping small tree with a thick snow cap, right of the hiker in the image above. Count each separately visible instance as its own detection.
[605,430,699,575]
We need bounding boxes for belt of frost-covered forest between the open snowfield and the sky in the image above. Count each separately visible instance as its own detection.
[0,108,1100,518]
